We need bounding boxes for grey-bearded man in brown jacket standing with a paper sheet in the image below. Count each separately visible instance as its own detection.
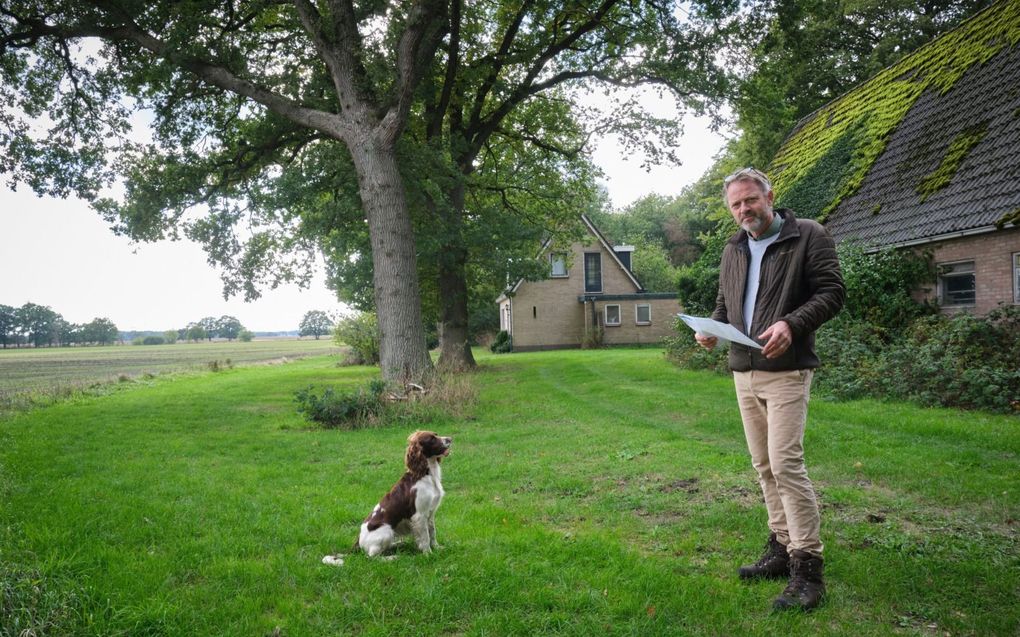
[695,168,846,611]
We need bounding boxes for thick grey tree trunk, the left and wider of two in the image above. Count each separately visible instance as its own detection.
[348,140,434,384]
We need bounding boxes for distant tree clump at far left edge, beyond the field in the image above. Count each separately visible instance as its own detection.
[0,303,119,349]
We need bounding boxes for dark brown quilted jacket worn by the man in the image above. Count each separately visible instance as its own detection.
[712,208,847,372]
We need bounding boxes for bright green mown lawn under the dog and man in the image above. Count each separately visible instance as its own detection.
[0,350,1020,636]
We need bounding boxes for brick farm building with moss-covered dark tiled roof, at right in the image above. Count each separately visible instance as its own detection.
[769,0,1020,314]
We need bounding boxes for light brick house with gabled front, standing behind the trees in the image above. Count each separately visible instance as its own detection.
[497,215,680,352]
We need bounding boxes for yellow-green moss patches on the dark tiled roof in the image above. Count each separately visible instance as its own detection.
[769,0,1020,219]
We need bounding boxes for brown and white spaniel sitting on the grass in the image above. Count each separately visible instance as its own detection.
[322,431,453,566]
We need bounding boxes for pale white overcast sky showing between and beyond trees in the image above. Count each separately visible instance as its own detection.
[0,101,723,331]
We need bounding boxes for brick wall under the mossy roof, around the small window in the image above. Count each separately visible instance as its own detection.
[925,227,1020,314]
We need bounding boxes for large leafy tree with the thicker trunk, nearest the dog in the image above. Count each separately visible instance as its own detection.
[0,0,449,380]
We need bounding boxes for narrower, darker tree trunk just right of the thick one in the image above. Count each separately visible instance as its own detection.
[439,181,475,372]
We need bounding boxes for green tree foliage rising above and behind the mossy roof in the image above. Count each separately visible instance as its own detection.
[732,0,992,168]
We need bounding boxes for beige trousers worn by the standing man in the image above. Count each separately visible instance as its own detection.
[733,369,822,556]
